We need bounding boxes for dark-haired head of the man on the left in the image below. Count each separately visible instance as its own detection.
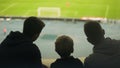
[23,17,45,41]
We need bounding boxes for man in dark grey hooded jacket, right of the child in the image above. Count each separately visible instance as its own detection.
[84,21,120,68]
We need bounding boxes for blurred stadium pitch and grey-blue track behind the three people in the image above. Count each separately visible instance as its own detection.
[0,0,120,67]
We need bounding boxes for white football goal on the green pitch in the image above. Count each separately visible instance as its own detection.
[37,7,61,17]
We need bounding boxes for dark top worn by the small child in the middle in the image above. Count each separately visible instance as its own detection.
[50,57,83,68]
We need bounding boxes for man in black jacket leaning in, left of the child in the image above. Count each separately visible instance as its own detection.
[0,17,45,68]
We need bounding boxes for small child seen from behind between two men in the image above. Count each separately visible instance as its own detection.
[51,35,83,68]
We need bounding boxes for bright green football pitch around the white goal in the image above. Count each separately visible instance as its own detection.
[0,0,120,19]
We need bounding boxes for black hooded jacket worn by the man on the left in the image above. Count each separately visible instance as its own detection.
[0,32,42,68]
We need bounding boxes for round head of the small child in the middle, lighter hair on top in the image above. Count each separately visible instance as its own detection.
[55,35,74,57]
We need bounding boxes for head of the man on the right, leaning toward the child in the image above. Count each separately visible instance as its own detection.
[84,21,105,45]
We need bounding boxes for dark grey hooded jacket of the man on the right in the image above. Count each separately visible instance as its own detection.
[84,38,120,68]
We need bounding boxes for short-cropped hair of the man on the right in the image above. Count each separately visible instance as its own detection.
[84,21,103,39]
